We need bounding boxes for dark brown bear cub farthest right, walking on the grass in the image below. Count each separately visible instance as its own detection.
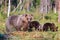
[43,23,58,32]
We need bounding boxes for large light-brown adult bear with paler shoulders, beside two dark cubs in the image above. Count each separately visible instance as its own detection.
[6,14,33,32]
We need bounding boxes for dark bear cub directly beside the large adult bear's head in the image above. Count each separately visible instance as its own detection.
[29,21,43,31]
